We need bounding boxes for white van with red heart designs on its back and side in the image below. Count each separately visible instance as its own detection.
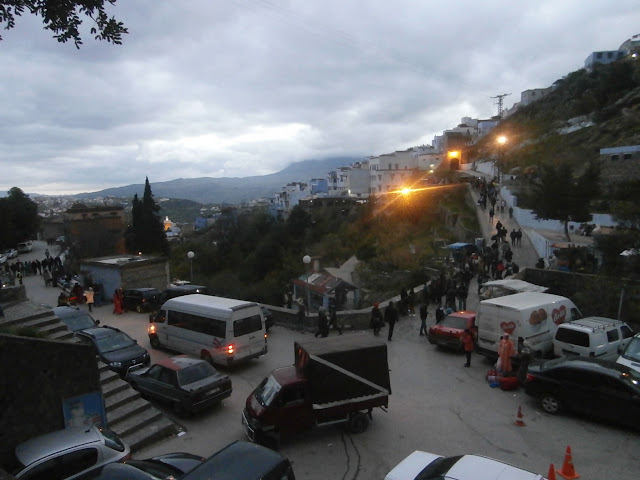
[476,292,582,358]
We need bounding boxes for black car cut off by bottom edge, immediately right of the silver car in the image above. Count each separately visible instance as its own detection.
[82,453,204,480]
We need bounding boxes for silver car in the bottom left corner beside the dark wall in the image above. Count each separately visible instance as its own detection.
[13,425,129,480]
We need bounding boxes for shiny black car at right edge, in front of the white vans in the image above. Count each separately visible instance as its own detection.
[524,357,640,428]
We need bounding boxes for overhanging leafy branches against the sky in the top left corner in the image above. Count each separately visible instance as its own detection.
[0,0,129,48]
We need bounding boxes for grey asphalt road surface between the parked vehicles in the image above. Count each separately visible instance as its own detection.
[13,242,640,480]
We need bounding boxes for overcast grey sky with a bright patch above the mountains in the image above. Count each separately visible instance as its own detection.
[0,0,640,194]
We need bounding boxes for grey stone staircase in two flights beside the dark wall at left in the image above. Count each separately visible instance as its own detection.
[0,301,180,452]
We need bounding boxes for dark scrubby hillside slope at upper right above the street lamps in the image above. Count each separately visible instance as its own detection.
[468,61,640,195]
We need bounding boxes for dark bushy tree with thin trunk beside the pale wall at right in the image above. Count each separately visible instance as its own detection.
[529,162,600,242]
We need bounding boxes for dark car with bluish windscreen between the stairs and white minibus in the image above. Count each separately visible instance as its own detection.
[76,326,151,378]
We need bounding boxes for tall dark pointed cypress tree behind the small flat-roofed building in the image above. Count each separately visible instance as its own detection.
[125,178,169,255]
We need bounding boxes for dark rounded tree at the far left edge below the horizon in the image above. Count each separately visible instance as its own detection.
[0,187,40,248]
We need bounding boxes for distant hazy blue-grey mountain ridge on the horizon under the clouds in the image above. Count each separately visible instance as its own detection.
[74,157,361,204]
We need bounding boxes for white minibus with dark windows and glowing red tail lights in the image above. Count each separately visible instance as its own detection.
[148,294,267,366]
